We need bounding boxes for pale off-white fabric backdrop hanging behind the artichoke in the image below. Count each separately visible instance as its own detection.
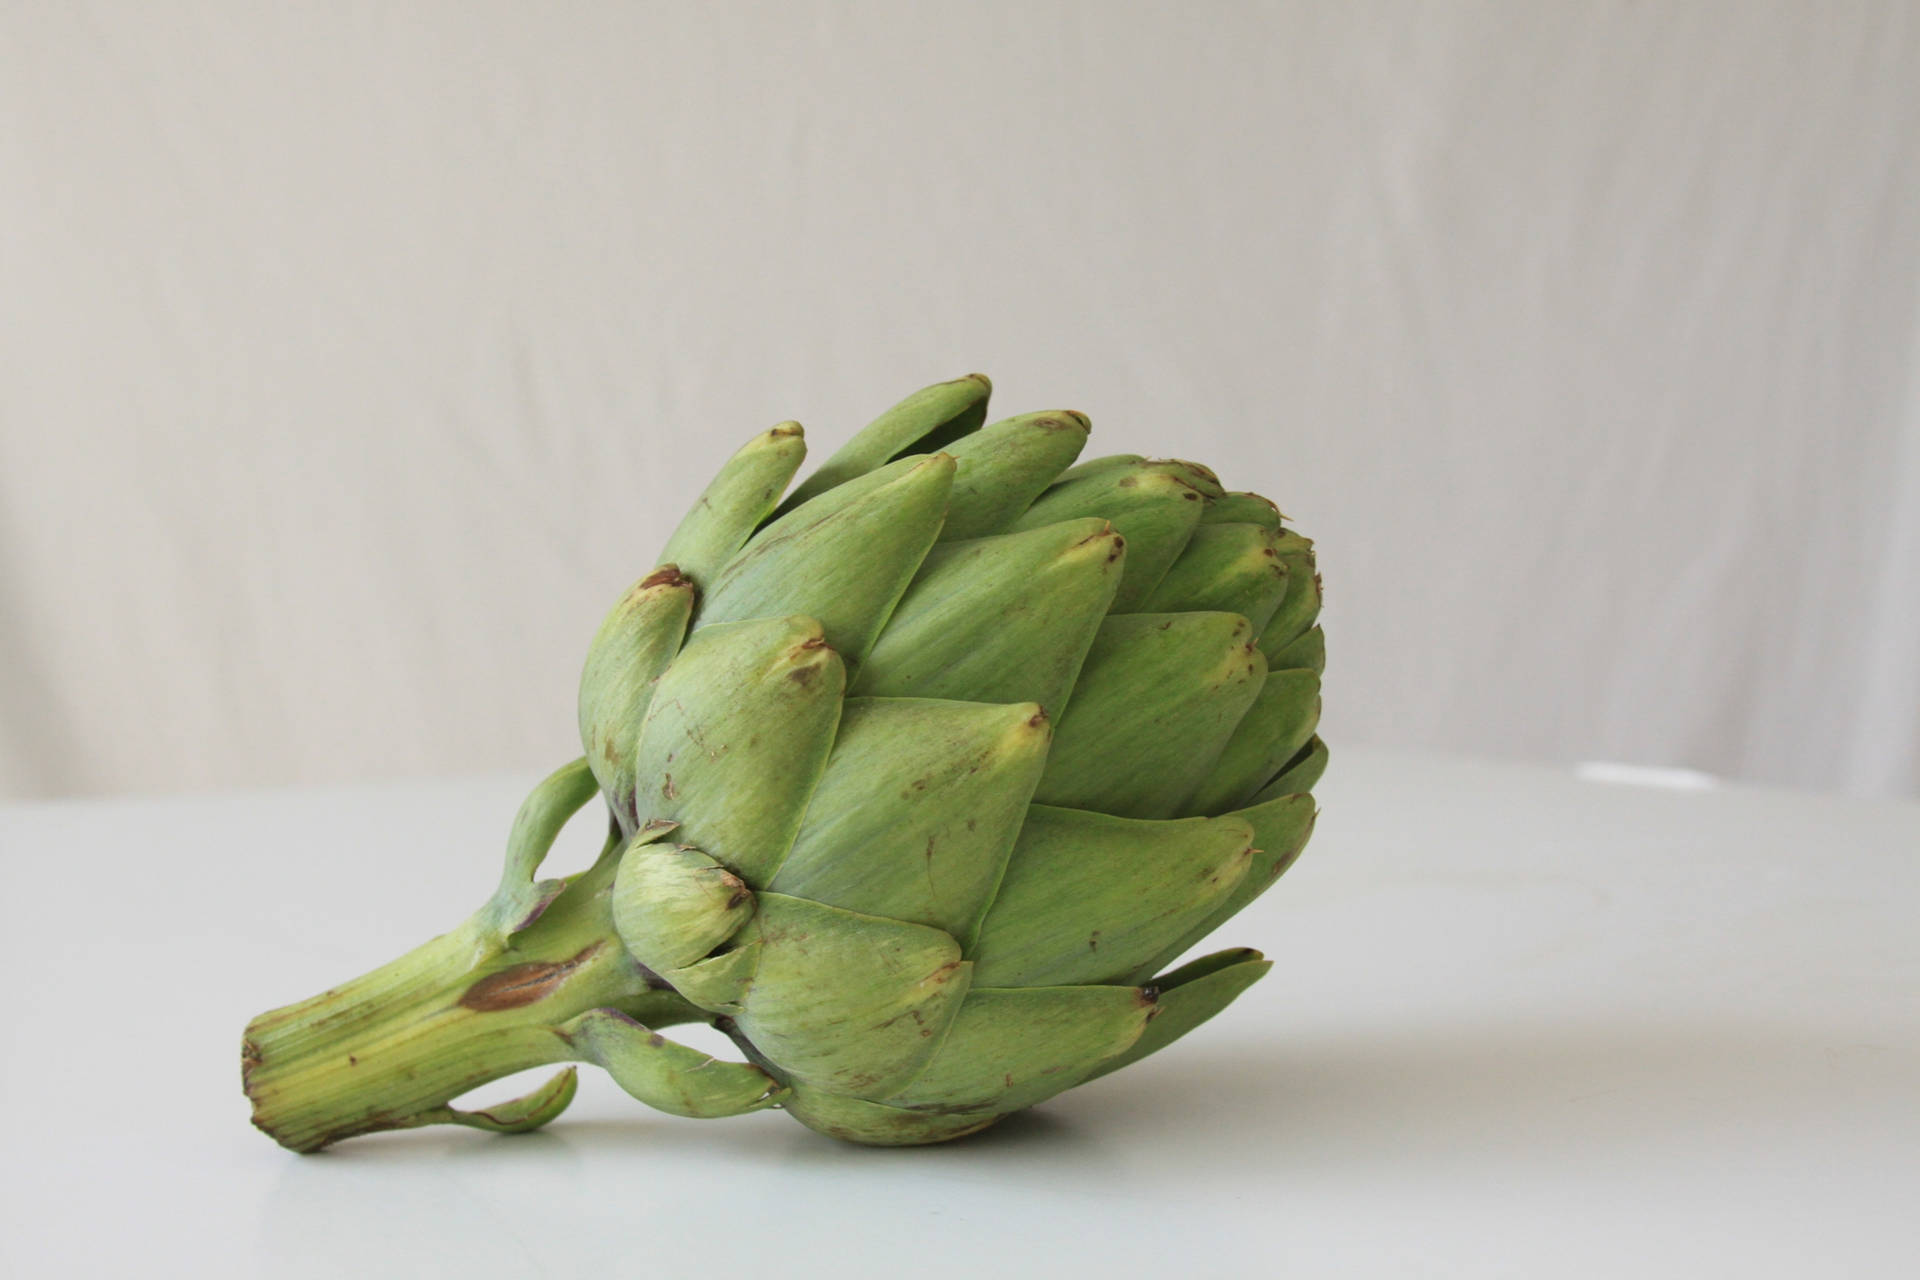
[0,0,1920,796]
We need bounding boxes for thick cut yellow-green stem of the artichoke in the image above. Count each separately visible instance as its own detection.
[242,867,697,1151]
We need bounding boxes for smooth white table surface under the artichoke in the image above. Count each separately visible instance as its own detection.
[0,750,1920,1280]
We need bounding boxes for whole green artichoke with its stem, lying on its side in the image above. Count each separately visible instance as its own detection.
[244,374,1327,1151]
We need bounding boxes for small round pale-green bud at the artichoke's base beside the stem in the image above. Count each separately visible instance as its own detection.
[612,844,753,975]
